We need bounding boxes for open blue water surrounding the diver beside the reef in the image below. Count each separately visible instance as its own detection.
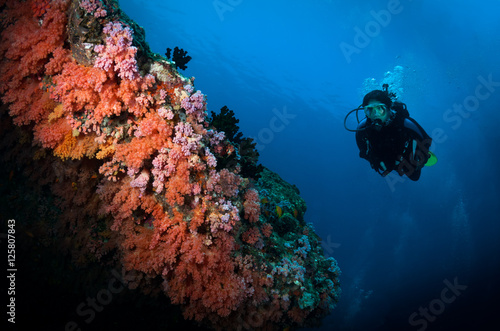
[120,0,500,331]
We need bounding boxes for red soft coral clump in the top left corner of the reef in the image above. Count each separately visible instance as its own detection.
[0,1,67,125]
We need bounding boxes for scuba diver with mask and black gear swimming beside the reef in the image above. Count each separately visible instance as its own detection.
[344,84,437,181]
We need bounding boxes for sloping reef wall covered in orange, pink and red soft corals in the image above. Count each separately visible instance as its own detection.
[0,0,340,329]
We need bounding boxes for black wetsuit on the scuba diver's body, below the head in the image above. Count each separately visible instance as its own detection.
[356,112,432,181]
